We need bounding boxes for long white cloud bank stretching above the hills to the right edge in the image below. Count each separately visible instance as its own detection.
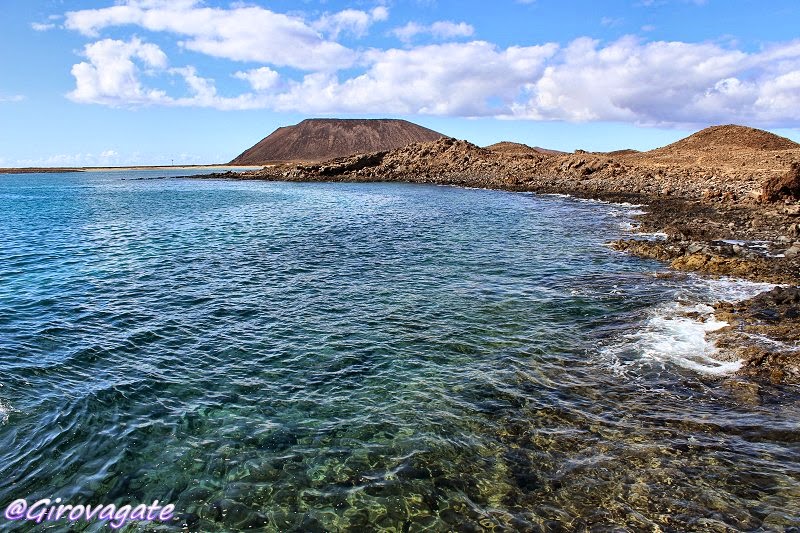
[64,37,800,126]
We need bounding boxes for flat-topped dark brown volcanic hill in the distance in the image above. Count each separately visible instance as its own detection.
[230,119,444,165]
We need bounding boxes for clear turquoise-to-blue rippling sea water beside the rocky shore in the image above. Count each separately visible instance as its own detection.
[0,171,800,531]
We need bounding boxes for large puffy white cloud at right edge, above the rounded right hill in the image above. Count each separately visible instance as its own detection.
[511,37,800,125]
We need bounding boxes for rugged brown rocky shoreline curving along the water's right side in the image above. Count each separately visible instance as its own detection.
[183,131,800,383]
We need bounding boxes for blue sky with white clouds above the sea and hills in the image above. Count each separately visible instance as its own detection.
[0,0,800,166]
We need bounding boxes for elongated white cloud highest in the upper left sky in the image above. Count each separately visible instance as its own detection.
[65,0,360,70]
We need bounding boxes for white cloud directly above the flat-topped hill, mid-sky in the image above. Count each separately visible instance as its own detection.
[274,41,557,116]
